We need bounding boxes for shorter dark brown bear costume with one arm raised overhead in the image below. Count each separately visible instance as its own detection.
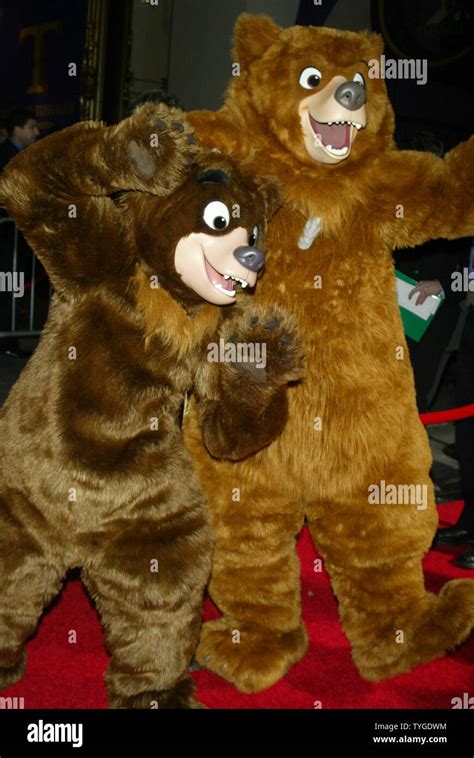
[0,104,301,708]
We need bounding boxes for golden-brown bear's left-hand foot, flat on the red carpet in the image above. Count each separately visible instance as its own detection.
[196,619,307,693]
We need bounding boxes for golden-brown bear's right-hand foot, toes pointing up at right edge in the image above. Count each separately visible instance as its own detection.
[352,579,474,682]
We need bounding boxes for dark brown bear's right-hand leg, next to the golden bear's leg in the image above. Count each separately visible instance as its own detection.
[82,490,212,708]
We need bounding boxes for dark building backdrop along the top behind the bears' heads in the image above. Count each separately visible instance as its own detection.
[0,0,474,147]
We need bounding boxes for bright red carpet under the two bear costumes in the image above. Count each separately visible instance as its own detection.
[2,503,474,708]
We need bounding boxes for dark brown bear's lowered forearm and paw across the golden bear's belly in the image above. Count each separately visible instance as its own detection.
[196,308,303,460]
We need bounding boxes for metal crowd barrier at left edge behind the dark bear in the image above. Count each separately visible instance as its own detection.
[0,217,51,338]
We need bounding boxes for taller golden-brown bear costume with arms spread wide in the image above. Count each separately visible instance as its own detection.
[186,14,474,692]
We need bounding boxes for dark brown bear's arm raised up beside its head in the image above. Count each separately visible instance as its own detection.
[0,103,196,289]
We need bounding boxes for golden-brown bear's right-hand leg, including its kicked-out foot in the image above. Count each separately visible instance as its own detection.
[310,484,474,681]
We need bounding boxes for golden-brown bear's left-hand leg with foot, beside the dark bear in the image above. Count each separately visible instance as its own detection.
[196,492,307,693]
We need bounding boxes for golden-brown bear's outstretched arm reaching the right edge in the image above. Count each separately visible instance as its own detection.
[373,137,474,248]
